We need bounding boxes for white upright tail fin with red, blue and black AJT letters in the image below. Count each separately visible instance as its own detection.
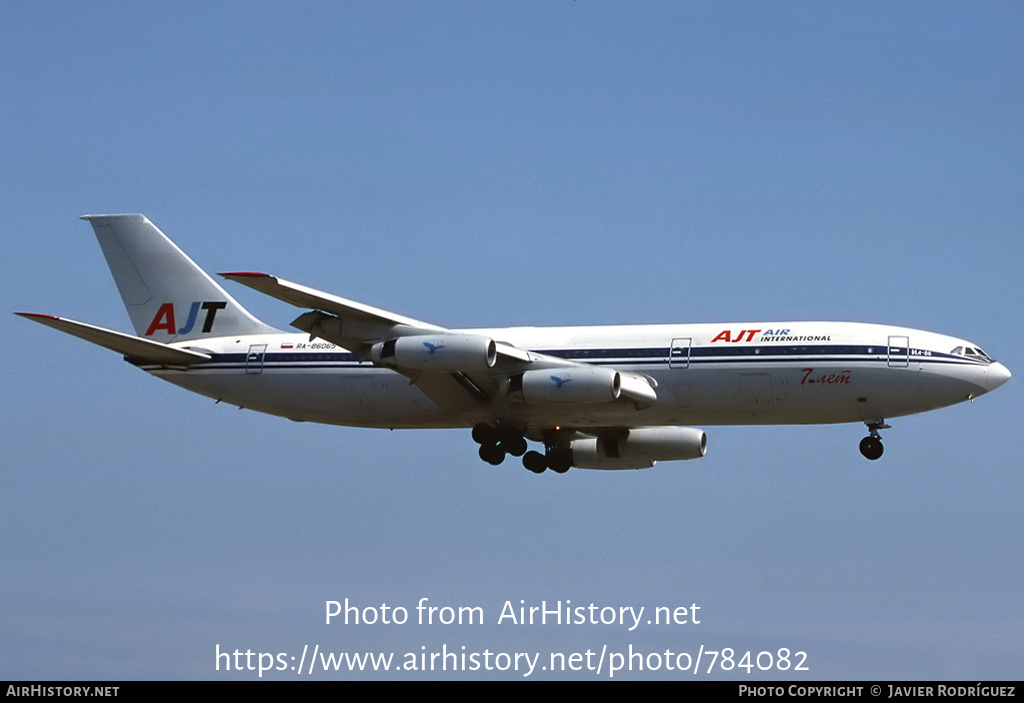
[82,215,271,343]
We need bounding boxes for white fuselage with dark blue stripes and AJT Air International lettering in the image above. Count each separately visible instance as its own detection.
[142,322,1009,428]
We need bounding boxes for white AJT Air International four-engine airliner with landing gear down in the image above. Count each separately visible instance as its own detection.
[15,214,1010,474]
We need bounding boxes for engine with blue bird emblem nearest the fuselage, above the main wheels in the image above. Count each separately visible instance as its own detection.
[509,366,622,405]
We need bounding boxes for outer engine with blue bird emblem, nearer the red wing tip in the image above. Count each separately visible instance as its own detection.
[370,334,498,372]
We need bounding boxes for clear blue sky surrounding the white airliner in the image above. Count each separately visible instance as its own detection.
[0,1,1024,680]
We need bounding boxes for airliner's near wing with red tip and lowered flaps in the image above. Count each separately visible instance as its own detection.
[220,271,656,410]
